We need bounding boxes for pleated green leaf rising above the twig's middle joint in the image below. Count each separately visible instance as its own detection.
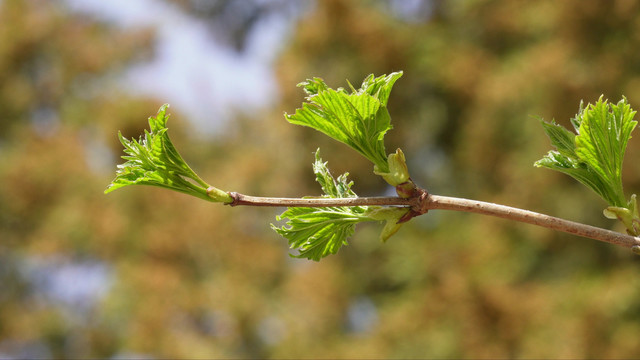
[285,72,402,173]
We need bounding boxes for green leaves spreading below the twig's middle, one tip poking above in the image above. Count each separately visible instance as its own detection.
[271,151,377,261]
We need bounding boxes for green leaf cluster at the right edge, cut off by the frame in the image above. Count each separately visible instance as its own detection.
[535,97,640,236]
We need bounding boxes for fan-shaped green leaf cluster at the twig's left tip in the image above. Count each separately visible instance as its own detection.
[105,104,233,202]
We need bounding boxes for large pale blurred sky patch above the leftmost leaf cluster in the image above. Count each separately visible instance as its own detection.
[66,0,304,132]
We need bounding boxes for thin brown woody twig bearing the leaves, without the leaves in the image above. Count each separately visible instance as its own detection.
[227,192,640,253]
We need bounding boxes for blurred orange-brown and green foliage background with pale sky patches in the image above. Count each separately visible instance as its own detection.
[0,0,640,359]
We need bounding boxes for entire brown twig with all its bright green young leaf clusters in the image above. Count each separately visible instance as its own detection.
[105,72,640,261]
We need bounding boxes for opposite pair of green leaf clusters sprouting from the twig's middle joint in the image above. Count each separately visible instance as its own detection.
[274,72,416,260]
